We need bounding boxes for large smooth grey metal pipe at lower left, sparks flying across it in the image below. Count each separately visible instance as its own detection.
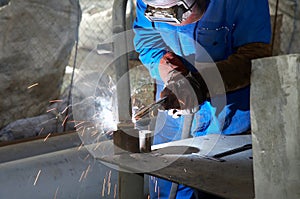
[0,132,117,199]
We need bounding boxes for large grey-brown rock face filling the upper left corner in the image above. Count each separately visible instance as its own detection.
[0,0,80,128]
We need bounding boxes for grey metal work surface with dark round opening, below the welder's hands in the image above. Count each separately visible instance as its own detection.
[95,134,254,199]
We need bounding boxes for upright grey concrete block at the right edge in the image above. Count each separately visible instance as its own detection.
[251,54,300,199]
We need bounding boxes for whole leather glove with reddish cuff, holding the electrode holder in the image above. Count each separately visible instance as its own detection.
[159,52,208,113]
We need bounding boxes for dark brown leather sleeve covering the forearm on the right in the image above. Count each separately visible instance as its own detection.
[196,42,271,98]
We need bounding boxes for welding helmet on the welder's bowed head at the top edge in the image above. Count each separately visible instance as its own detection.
[143,0,197,23]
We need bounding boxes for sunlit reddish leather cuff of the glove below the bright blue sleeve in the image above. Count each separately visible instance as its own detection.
[159,52,189,83]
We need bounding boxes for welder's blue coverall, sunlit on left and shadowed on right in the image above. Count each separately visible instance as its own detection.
[134,0,271,199]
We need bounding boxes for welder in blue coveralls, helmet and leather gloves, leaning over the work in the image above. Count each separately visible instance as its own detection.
[134,0,271,199]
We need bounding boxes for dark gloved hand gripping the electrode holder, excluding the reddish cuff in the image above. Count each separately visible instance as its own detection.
[160,74,208,114]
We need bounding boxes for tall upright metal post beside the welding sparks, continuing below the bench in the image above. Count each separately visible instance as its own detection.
[112,0,144,199]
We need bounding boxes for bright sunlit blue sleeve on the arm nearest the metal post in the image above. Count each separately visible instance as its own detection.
[133,0,167,80]
